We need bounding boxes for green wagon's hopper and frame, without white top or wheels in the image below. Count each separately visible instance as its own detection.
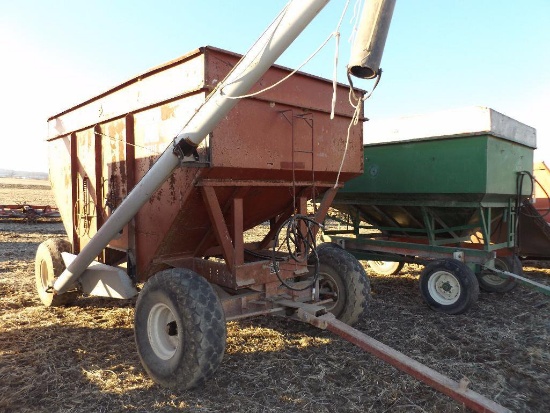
[327,116,548,294]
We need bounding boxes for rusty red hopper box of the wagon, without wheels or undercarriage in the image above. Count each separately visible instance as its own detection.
[48,47,363,281]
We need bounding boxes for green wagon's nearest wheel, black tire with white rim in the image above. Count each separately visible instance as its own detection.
[420,259,479,314]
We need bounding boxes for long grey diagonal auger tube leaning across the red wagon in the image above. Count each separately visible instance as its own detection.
[53,0,329,294]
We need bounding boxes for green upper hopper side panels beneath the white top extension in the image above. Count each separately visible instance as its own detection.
[339,135,533,202]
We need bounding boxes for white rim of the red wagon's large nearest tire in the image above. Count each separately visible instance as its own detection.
[147,303,179,360]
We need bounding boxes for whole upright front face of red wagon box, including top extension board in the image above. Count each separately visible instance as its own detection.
[206,46,363,180]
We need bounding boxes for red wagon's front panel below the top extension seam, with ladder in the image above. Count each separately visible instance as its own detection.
[210,99,363,181]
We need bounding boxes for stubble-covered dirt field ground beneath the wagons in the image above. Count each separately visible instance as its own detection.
[0,180,550,413]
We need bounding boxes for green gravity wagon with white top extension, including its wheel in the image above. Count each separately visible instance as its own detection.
[329,107,550,314]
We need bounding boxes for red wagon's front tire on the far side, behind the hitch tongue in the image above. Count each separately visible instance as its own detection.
[317,243,370,325]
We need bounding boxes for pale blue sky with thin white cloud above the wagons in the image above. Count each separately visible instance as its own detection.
[0,0,550,172]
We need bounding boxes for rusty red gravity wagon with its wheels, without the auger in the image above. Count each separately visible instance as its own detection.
[37,47,369,387]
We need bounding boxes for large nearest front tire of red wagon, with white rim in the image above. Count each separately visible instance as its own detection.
[134,268,227,390]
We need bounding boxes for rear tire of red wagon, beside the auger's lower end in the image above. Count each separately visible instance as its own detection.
[34,238,79,307]
